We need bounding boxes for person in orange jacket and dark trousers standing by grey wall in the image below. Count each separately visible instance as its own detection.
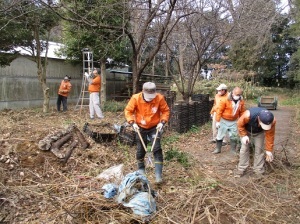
[56,76,72,112]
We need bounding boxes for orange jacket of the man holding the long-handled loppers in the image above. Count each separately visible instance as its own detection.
[124,92,170,129]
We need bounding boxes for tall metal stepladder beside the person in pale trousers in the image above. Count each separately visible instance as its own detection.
[74,49,94,115]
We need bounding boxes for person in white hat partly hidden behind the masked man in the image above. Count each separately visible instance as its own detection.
[210,83,228,145]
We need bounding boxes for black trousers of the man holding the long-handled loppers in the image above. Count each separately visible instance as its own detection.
[136,126,163,163]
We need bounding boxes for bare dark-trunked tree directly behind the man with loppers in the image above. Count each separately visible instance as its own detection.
[48,0,188,92]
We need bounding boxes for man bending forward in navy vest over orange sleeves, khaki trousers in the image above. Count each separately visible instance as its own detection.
[234,107,276,177]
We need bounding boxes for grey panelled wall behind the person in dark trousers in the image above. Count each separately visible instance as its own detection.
[0,56,82,109]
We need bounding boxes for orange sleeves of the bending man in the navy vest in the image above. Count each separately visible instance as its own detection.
[237,110,276,152]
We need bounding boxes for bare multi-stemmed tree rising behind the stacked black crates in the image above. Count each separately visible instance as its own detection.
[166,0,232,101]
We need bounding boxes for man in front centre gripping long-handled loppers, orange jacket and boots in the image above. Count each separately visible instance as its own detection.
[124,82,170,183]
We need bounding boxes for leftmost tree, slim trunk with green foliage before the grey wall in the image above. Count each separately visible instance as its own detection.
[2,0,58,112]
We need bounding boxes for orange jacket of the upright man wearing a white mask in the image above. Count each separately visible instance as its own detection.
[216,94,246,122]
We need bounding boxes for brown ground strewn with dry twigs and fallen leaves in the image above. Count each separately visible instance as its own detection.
[0,100,300,224]
